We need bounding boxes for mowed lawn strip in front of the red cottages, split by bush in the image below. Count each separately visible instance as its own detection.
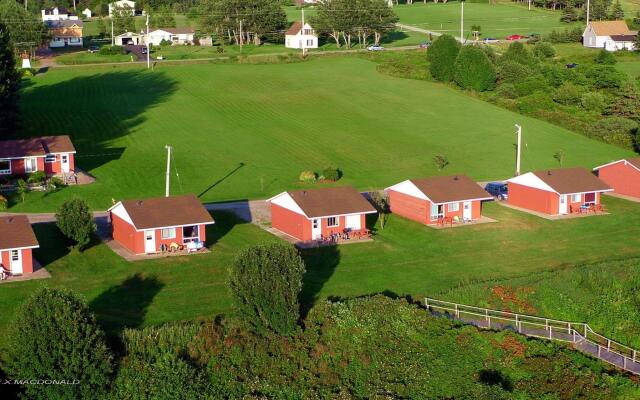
[0,197,640,340]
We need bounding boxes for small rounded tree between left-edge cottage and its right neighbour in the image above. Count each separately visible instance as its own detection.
[56,199,96,250]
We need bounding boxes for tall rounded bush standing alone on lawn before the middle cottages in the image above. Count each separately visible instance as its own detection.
[229,243,305,335]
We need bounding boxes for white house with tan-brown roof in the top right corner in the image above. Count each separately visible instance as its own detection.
[582,21,638,51]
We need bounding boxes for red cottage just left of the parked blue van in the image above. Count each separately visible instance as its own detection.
[386,175,493,225]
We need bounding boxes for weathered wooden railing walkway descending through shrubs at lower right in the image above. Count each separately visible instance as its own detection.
[424,298,640,375]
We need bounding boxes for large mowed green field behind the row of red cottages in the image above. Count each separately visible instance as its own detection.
[11,56,630,211]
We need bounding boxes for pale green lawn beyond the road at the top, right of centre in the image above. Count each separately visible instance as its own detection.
[394,2,581,39]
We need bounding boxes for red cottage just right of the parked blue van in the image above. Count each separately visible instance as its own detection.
[507,168,613,215]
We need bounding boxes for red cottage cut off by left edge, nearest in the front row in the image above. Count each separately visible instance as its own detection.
[0,215,40,275]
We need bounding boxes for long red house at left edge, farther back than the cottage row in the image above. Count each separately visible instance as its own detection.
[0,135,76,176]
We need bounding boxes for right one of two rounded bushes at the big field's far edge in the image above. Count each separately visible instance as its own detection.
[454,46,496,92]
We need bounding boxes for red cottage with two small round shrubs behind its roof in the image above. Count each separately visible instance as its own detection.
[267,187,376,241]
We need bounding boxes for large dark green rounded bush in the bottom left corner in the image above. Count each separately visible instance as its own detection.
[4,288,112,399]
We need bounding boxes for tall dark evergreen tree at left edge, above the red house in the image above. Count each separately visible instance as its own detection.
[0,22,20,139]
